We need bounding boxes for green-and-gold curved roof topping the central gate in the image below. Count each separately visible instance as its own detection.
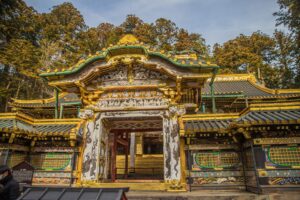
[39,34,219,77]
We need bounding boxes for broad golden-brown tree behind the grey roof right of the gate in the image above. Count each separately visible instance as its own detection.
[213,32,275,87]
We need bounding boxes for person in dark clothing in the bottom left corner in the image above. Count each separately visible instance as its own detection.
[0,165,20,200]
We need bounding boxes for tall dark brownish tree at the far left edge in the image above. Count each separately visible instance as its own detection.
[0,0,48,111]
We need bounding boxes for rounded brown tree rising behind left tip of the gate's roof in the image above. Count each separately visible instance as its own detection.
[40,3,87,68]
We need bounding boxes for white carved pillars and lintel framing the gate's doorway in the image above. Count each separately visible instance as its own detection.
[82,106,183,183]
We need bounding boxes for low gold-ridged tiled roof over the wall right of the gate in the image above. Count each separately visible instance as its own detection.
[181,103,300,134]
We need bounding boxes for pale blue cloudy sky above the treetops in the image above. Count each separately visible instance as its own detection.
[25,0,279,45]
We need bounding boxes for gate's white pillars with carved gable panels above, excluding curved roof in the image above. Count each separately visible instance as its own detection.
[77,63,189,188]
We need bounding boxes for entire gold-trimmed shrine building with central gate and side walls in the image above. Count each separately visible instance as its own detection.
[0,34,300,192]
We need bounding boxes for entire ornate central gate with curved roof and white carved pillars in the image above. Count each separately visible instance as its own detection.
[41,34,218,189]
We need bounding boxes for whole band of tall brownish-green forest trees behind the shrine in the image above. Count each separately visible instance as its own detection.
[0,0,300,112]
